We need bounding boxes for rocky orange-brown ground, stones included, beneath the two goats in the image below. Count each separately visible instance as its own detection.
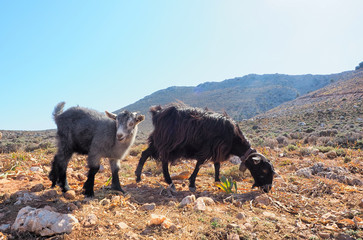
[0,145,363,239]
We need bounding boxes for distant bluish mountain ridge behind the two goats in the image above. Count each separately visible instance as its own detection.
[115,71,354,134]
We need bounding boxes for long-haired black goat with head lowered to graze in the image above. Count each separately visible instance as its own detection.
[135,105,274,192]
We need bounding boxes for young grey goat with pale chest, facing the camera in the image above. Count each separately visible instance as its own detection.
[49,102,144,197]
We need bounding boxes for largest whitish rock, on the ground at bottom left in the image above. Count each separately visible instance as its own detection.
[12,206,78,236]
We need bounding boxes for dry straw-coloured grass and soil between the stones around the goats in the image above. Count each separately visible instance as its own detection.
[0,143,363,239]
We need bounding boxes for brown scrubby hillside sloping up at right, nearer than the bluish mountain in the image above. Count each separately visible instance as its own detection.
[240,69,363,149]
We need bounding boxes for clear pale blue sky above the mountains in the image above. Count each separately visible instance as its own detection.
[0,0,363,130]
